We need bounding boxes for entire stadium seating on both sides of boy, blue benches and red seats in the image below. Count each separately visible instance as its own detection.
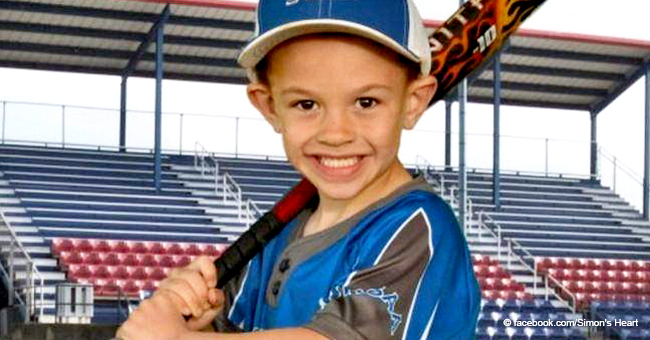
[0,146,650,339]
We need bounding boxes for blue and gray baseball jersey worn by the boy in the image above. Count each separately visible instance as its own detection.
[215,177,481,340]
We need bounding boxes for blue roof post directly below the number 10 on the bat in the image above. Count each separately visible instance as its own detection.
[492,52,501,210]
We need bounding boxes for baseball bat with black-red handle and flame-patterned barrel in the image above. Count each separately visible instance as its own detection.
[214,0,545,288]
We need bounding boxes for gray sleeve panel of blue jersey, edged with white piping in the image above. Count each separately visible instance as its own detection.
[306,209,433,340]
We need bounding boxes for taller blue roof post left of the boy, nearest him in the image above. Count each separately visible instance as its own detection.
[154,23,165,192]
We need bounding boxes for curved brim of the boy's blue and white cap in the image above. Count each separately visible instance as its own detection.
[237,19,421,69]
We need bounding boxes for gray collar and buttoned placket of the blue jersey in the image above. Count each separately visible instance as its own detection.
[266,176,433,307]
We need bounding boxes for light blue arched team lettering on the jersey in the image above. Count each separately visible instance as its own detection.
[318,286,402,336]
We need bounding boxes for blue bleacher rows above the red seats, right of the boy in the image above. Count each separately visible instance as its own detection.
[432,171,650,259]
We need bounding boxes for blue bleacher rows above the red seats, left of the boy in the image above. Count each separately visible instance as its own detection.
[0,145,246,322]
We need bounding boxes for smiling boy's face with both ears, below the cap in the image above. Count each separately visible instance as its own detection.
[248,35,435,200]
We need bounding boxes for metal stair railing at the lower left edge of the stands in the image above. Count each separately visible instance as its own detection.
[0,207,45,322]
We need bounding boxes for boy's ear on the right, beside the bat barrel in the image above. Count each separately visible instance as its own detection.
[403,75,438,130]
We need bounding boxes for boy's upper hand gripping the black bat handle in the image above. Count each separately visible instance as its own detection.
[153,256,224,331]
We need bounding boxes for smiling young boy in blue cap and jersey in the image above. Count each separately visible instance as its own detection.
[118,0,480,340]
